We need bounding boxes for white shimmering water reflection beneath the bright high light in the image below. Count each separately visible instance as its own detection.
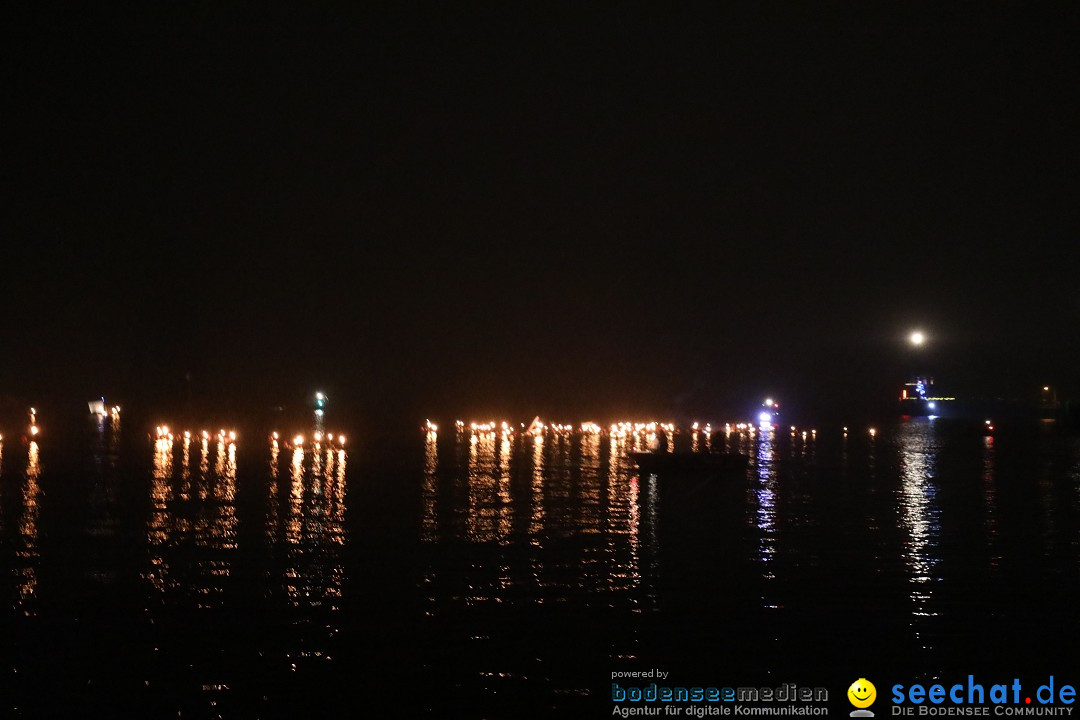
[896,420,941,649]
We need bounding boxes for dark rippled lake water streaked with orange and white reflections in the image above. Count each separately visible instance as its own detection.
[0,420,1080,718]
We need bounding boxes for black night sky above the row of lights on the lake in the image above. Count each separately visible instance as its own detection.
[0,3,1080,420]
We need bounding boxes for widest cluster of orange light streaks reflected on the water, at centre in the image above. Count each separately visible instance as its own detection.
[420,427,659,614]
